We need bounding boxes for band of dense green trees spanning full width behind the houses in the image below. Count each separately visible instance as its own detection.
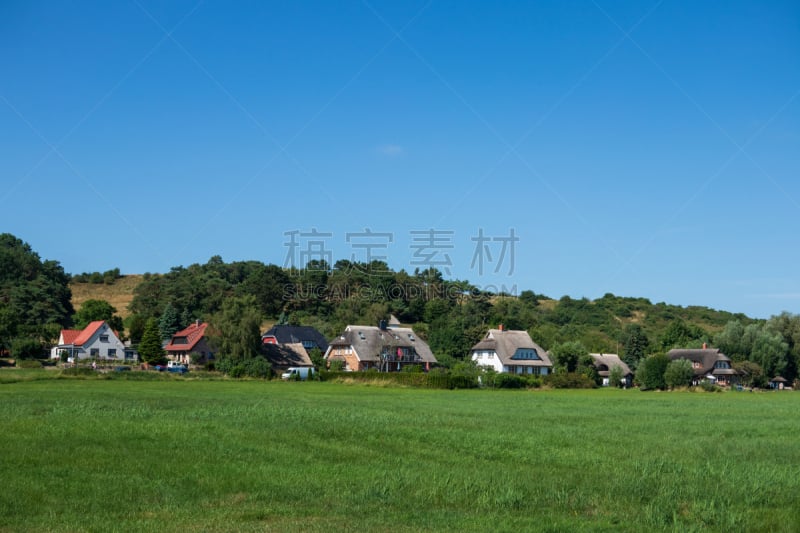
[0,234,800,381]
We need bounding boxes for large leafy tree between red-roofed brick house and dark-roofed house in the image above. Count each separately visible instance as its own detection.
[211,295,262,360]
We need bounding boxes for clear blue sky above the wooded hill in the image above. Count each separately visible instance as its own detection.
[0,0,800,317]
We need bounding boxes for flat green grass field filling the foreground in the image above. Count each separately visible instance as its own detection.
[0,376,800,531]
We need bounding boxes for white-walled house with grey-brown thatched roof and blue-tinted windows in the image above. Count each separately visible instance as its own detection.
[470,326,553,376]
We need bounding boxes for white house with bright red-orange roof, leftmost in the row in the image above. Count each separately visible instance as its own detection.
[50,320,138,361]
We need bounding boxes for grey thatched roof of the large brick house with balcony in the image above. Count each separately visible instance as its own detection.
[330,325,437,363]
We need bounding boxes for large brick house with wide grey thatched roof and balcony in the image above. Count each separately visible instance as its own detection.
[325,323,437,372]
